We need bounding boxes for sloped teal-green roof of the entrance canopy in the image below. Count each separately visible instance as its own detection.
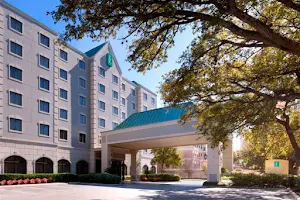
[114,105,186,130]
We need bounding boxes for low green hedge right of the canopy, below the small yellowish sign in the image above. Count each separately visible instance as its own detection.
[231,173,298,188]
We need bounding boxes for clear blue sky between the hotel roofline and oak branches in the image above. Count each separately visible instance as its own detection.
[6,0,193,107]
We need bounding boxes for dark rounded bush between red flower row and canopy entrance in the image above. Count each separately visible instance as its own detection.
[78,173,121,184]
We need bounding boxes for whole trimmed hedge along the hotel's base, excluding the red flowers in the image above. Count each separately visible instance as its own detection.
[0,173,121,184]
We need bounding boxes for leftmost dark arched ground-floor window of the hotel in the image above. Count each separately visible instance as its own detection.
[4,156,27,174]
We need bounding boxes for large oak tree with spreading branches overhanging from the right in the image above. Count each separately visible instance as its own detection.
[50,0,300,160]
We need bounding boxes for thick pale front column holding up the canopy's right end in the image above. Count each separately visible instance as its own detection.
[207,144,222,182]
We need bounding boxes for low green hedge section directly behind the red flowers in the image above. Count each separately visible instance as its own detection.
[0,174,78,182]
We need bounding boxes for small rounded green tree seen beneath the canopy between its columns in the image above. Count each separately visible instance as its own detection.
[151,148,183,171]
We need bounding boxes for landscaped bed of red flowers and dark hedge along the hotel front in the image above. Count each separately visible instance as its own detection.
[0,173,121,185]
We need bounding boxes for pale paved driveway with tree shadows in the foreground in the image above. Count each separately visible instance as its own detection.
[0,181,294,200]
